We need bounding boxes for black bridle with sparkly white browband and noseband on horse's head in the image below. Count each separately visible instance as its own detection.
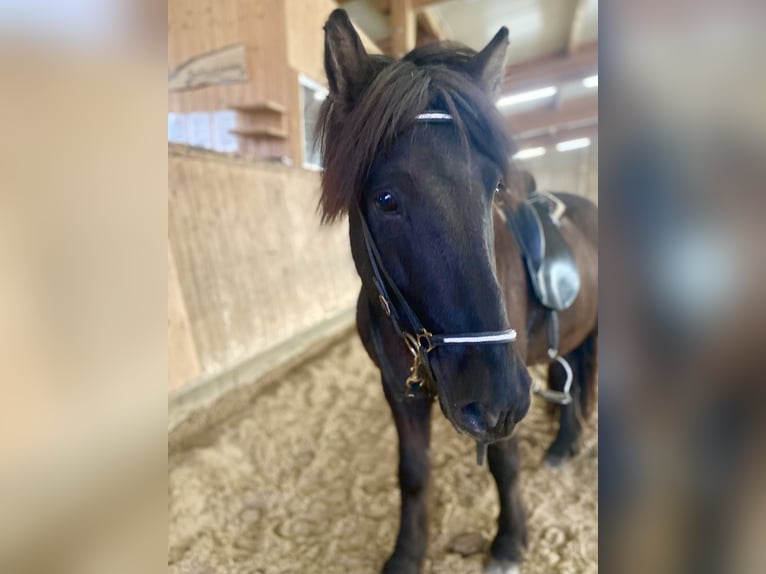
[357,111,516,398]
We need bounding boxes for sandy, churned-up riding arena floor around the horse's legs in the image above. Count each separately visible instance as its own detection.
[168,335,598,574]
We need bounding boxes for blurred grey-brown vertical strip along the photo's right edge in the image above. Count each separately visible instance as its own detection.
[600,1,766,574]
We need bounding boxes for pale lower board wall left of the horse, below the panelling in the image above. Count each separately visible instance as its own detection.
[168,146,359,387]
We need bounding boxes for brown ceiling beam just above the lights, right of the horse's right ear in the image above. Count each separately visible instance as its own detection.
[501,42,598,94]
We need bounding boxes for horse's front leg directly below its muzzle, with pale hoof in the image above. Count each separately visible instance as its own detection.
[485,437,527,574]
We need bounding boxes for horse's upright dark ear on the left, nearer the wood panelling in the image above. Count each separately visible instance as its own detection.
[324,8,370,103]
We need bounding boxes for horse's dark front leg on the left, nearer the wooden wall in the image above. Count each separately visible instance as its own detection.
[383,384,432,574]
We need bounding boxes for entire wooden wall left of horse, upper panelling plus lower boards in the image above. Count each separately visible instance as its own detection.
[168,0,388,390]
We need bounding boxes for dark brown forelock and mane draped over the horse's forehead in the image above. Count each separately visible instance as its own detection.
[317,42,515,222]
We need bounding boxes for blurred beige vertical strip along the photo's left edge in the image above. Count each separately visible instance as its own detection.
[0,0,167,574]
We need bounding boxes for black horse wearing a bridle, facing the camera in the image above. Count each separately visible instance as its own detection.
[319,10,597,574]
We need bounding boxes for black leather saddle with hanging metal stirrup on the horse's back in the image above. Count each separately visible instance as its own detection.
[501,191,580,404]
